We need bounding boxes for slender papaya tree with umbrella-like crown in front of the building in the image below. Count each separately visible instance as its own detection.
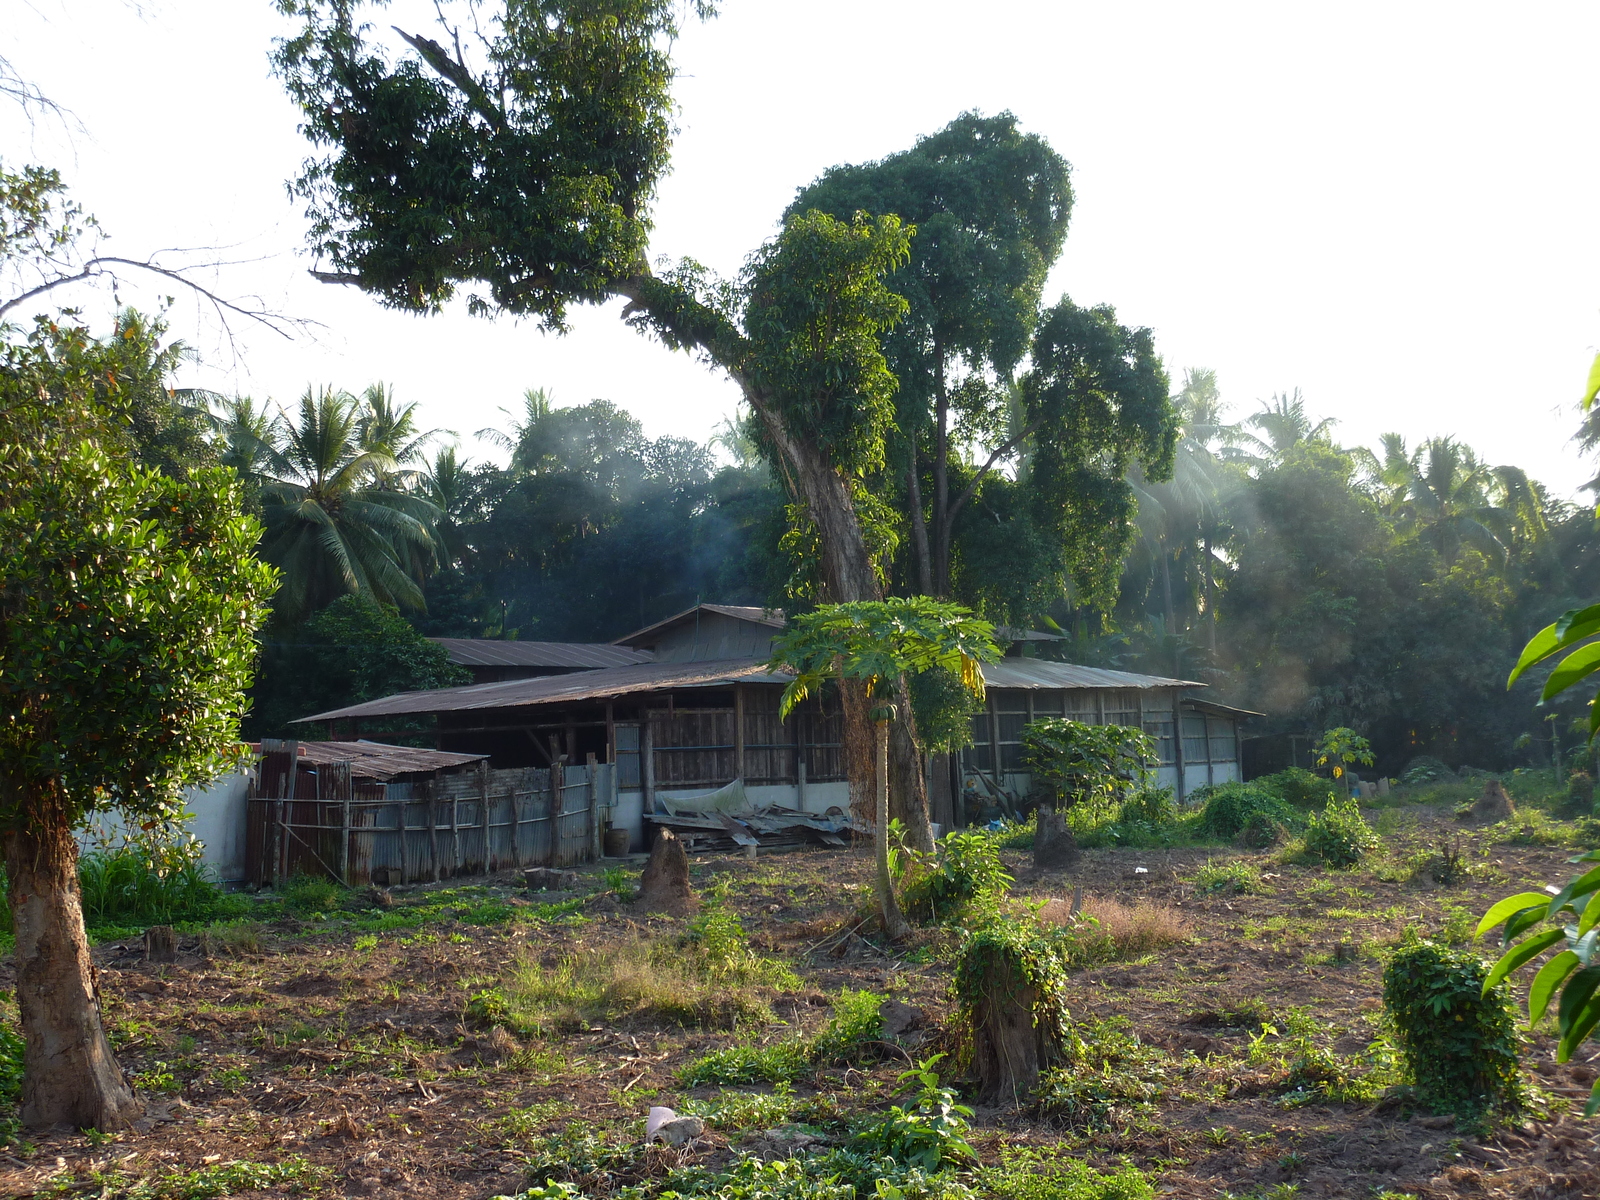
[771,597,1000,941]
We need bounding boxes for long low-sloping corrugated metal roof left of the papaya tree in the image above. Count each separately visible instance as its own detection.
[299,658,790,722]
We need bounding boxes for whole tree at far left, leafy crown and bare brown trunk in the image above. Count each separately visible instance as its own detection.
[0,322,275,1130]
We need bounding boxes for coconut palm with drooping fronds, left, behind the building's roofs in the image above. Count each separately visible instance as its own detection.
[261,387,440,621]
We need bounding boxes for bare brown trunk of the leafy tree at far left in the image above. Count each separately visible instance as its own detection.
[5,797,141,1131]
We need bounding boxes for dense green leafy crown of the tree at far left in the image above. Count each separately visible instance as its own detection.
[0,326,272,822]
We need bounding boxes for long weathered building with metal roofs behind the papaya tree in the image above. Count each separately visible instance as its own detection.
[302,605,1256,848]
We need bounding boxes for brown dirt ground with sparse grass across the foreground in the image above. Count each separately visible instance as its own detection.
[0,810,1600,1200]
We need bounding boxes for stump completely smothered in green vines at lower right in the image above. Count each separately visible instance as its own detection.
[1384,941,1526,1120]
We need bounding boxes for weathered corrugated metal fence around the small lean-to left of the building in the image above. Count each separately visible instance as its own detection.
[246,742,616,886]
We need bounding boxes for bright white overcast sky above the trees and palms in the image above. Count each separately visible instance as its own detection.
[0,0,1600,493]
